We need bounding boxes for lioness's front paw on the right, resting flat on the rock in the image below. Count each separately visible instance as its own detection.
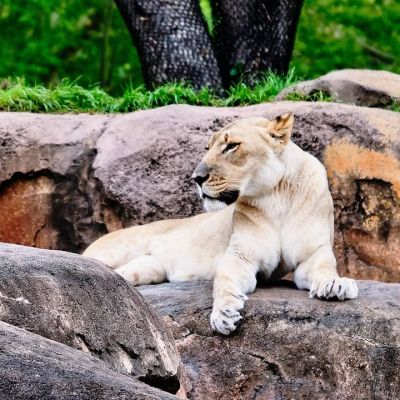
[310,277,358,300]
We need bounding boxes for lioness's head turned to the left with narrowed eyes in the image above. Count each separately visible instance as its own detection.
[193,113,293,211]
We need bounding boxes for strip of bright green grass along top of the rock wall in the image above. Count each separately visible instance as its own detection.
[0,70,296,113]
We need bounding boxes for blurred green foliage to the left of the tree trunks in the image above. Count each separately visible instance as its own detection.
[0,0,143,92]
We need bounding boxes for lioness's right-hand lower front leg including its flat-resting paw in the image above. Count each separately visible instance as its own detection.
[294,245,358,300]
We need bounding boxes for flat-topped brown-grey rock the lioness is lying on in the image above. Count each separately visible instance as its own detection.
[140,281,400,400]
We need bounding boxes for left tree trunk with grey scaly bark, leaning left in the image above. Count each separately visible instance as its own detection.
[115,0,222,89]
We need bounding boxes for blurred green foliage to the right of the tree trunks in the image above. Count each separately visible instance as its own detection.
[292,0,400,78]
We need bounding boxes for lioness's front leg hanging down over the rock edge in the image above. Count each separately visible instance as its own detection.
[210,252,257,335]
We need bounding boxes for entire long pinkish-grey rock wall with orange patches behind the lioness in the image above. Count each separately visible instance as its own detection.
[0,102,400,282]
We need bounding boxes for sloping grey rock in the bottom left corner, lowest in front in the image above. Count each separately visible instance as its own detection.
[0,322,177,400]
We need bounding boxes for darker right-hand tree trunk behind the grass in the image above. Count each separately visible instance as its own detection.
[212,0,303,86]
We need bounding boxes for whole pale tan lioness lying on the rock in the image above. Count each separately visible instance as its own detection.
[84,113,358,335]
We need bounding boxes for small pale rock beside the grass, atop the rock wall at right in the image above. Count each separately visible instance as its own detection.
[277,69,400,107]
